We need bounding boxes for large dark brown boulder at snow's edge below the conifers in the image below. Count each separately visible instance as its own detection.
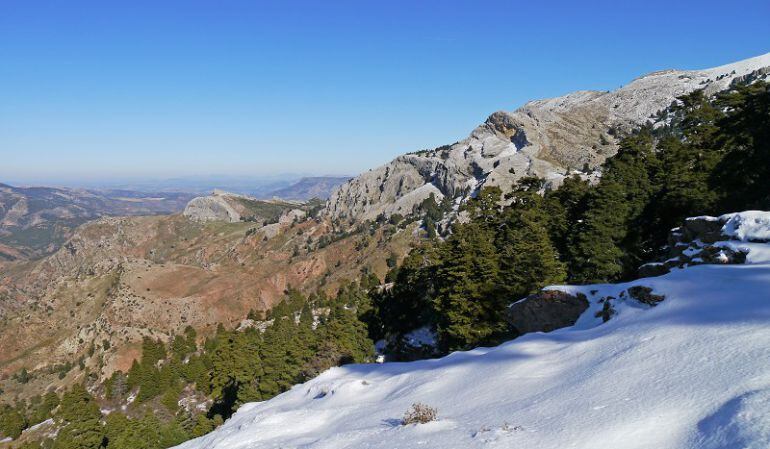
[508,290,588,334]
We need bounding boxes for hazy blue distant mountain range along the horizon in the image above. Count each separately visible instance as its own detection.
[0,176,350,261]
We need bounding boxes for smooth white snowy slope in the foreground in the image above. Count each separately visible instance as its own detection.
[174,212,770,449]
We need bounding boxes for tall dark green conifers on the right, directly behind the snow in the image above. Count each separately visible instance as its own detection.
[362,82,770,350]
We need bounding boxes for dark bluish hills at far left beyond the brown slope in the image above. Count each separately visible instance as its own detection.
[0,184,192,260]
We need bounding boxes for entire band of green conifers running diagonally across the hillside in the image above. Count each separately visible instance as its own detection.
[0,82,770,449]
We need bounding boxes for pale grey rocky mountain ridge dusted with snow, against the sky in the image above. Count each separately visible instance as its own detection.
[327,53,770,221]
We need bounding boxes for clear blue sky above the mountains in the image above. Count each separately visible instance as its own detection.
[0,0,770,181]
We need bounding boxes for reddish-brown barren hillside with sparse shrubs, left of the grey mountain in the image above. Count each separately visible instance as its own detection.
[0,204,416,400]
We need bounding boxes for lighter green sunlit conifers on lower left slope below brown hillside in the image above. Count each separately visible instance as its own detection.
[0,284,378,449]
